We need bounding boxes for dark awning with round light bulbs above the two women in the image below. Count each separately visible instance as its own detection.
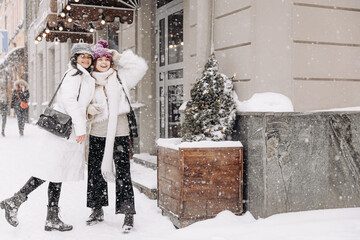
[35,0,139,43]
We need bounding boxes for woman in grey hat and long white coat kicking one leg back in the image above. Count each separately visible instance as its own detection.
[0,43,95,231]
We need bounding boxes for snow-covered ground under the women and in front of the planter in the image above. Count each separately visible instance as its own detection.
[0,119,360,240]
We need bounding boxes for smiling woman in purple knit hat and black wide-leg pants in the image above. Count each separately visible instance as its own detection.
[86,40,148,232]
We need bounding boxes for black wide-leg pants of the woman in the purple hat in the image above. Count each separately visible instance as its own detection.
[87,135,136,214]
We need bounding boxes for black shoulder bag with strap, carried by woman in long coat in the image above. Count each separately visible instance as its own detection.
[36,73,81,139]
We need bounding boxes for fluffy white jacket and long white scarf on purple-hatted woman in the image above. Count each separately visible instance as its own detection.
[92,50,148,182]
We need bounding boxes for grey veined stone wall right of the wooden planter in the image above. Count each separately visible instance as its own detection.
[233,112,360,218]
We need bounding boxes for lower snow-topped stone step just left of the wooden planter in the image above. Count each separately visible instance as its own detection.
[131,161,157,199]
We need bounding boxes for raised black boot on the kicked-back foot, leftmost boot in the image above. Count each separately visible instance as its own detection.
[0,192,27,227]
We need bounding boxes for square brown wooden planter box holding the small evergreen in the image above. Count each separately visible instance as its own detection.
[157,141,243,228]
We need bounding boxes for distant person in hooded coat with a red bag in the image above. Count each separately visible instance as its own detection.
[11,79,30,136]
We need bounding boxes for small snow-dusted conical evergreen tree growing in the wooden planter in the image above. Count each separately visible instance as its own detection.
[181,54,236,142]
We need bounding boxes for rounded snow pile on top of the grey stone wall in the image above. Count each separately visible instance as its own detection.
[235,92,294,112]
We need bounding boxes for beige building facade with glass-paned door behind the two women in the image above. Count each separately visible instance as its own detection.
[26,0,360,154]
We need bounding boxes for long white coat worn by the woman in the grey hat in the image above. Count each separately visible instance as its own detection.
[31,64,95,182]
